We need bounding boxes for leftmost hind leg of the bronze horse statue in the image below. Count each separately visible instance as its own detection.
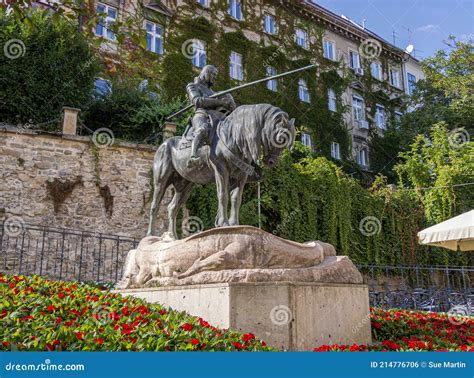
[147,142,173,236]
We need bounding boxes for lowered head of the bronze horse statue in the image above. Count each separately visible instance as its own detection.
[262,112,296,168]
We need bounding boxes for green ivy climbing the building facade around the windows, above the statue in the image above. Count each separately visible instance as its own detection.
[157,0,358,158]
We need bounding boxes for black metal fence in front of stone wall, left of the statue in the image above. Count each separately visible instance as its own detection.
[0,224,138,282]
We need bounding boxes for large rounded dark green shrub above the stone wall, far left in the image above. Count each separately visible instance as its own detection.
[0,10,99,129]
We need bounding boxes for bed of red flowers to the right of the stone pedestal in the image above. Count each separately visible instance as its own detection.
[314,308,474,352]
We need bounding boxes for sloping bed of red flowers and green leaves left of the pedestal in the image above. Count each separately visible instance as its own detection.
[0,273,271,351]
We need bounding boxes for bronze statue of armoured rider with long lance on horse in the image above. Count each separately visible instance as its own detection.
[147,65,315,239]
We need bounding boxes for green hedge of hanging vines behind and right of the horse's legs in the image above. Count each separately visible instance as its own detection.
[187,145,467,265]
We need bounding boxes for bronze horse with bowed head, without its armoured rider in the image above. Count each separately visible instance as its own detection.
[147,104,296,239]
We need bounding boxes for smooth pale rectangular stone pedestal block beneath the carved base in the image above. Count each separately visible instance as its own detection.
[117,282,371,350]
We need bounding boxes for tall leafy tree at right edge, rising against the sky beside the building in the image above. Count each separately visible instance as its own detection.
[370,37,474,181]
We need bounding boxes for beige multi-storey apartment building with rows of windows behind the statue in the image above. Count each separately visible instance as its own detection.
[52,0,423,170]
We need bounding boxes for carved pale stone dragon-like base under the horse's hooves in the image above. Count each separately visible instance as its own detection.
[117,226,362,289]
